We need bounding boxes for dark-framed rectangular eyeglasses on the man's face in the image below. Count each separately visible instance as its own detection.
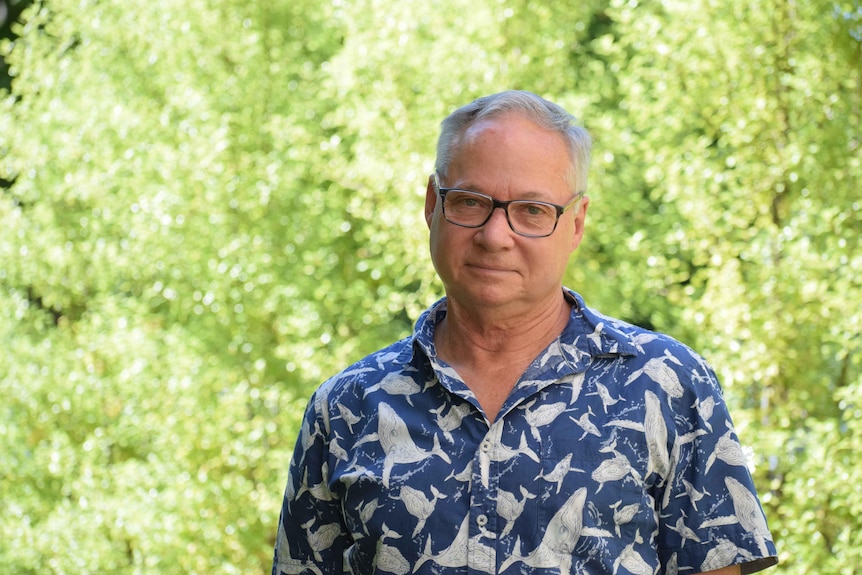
[434,172,584,238]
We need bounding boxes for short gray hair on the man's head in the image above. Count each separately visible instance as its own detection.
[434,90,592,193]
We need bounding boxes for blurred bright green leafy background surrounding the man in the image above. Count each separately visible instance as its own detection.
[0,0,862,575]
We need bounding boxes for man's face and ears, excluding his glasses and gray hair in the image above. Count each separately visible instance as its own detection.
[425,113,589,313]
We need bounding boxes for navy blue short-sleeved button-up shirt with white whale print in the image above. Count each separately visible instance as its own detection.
[272,292,776,575]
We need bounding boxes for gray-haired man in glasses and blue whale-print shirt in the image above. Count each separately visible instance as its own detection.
[272,92,777,575]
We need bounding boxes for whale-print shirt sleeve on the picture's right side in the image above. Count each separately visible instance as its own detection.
[657,355,778,575]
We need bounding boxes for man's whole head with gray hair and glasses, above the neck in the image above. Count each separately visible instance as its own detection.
[425,92,590,318]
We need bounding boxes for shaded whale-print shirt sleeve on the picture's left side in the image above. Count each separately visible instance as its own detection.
[272,390,350,575]
